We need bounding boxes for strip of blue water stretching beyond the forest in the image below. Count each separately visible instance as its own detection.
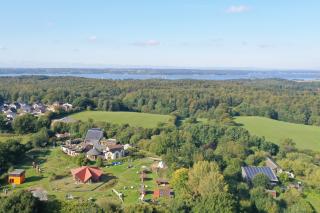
[0,69,320,81]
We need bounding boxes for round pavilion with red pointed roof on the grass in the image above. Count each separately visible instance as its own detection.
[71,166,102,183]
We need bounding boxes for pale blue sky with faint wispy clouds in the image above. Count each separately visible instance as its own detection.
[0,0,320,69]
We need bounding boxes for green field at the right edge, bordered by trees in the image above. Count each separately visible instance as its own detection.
[235,116,320,151]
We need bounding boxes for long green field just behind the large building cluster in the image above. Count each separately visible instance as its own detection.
[70,111,171,128]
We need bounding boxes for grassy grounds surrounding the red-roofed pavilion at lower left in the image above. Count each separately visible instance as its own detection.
[8,148,162,205]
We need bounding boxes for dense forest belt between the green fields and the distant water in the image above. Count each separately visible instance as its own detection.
[0,77,320,125]
